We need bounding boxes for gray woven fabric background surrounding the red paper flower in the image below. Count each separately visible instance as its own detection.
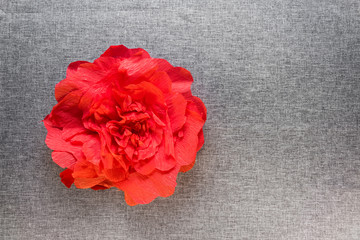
[0,0,360,240]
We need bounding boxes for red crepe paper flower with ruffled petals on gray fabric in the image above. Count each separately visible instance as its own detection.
[44,45,206,205]
